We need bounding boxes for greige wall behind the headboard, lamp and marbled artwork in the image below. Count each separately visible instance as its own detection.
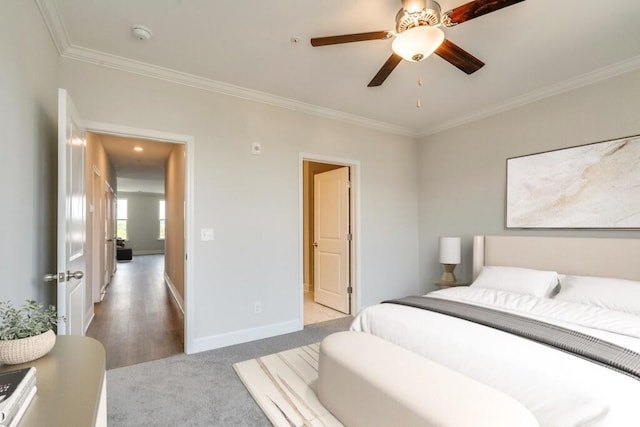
[419,71,640,290]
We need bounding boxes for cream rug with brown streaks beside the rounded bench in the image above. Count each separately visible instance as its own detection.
[233,343,342,427]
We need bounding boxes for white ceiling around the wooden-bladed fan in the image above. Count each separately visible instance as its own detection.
[36,0,640,136]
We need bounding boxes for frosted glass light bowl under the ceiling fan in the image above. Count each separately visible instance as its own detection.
[391,25,444,62]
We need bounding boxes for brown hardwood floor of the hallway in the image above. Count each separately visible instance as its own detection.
[87,255,184,369]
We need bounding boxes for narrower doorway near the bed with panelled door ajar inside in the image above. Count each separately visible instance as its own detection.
[301,155,357,325]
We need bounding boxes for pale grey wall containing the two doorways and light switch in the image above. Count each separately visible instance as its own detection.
[60,59,418,351]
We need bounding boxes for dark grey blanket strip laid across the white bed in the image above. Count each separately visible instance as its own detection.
[383,296,640,381]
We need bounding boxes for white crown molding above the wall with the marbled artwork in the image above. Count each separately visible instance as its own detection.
[419,56,640,137]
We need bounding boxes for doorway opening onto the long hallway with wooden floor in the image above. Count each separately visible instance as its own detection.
[82,126,190,368]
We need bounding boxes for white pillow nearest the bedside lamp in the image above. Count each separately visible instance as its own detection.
[471,266,558,298]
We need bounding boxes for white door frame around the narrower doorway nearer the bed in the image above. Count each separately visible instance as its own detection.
[298,153,363,329]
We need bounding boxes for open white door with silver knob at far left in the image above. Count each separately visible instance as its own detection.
[57,89,86,335]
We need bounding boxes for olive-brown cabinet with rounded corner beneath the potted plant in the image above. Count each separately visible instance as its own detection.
[0,335,107,427]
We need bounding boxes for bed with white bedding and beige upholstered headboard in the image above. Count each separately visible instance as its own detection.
[351,236,640,427]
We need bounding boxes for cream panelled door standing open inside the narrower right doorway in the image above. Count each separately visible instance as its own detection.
[313,167,350,314]
